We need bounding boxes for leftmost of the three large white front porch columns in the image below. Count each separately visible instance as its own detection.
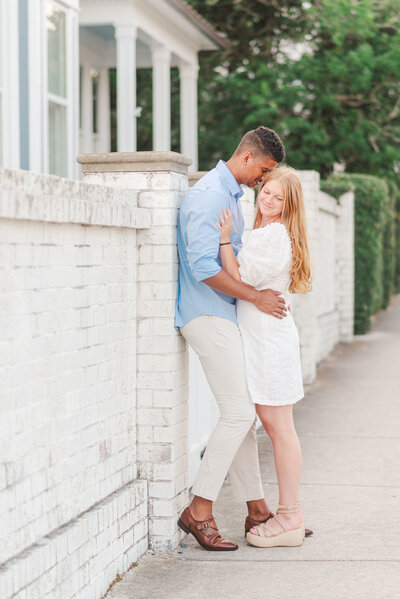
[115,25,136,152]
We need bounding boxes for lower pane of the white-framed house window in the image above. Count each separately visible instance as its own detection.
[49,102,67,177]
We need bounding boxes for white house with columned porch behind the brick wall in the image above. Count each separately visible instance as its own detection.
[6,0,223,178]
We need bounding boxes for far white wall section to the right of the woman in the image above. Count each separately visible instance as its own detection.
[292,171,354,383]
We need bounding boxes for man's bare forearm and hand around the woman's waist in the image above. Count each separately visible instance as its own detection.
[203,269,286,318]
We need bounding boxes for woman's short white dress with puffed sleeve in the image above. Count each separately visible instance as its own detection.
[236,223,304,406]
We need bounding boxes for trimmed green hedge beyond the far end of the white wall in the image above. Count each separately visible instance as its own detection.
[322,174,394,334]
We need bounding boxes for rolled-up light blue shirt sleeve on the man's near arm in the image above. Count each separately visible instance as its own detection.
[186,190,228,282]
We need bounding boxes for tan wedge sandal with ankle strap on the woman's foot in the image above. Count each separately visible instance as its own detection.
[246,502,305,547]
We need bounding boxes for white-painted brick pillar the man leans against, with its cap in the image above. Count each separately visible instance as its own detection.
[79,153,188,550]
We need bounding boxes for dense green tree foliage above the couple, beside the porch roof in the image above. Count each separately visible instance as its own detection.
[190,0,400,178]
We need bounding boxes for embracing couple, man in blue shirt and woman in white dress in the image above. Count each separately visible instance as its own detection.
[175,127,312,551]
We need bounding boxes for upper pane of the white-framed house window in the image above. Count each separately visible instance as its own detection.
[47,2,66,98]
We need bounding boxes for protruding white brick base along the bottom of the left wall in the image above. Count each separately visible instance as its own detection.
[0,481,148,599]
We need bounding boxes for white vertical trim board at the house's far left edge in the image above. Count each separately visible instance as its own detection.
[0,0,20,168]
